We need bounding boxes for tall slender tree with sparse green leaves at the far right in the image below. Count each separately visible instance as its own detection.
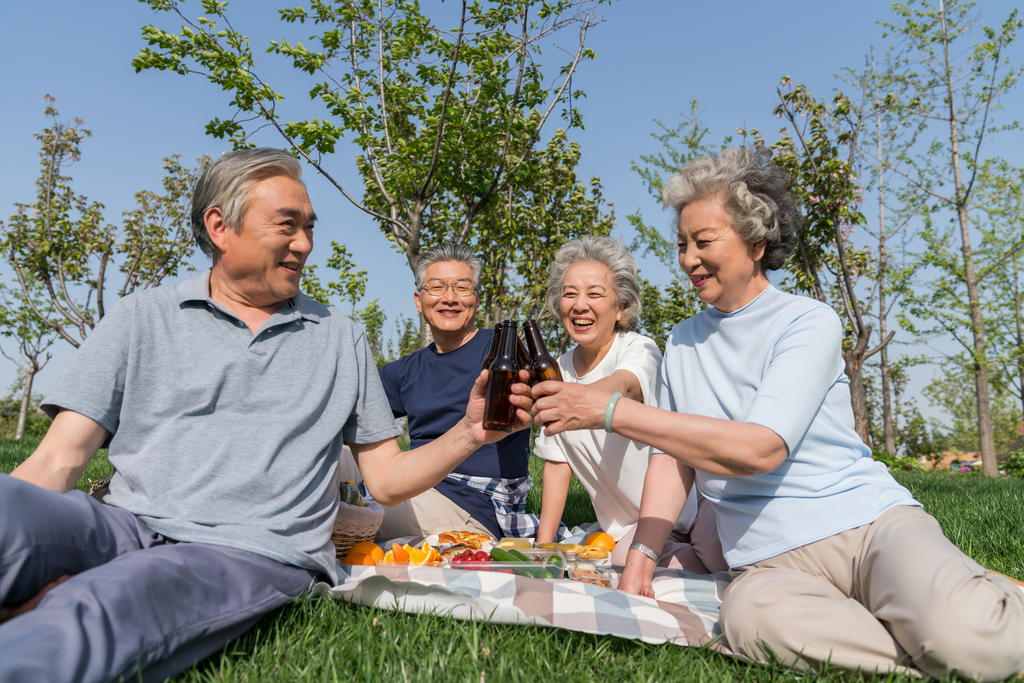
[883,0,1024,476]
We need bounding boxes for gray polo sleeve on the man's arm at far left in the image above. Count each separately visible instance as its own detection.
[42,297,133,435]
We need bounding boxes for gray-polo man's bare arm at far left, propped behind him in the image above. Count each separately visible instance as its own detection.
[10,411,110,494]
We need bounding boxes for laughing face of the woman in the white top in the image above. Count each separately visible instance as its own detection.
[561,261,623,347]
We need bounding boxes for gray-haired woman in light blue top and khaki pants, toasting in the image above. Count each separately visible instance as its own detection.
[534,148,1024,680]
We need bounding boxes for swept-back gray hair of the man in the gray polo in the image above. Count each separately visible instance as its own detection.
[191,147,302,256]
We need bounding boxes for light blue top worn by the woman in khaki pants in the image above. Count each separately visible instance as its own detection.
[658,286,920,567]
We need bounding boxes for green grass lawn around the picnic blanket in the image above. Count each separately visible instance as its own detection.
[0,439,1024,683]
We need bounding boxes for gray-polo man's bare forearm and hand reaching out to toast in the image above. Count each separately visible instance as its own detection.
[348,371,534,507]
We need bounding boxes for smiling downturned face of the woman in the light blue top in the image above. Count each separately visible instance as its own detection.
[678,196,768,313]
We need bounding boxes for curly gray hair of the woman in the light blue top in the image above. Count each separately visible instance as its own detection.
[662,147,803,270]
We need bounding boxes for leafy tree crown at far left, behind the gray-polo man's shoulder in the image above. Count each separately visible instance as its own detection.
[0,96,209,348]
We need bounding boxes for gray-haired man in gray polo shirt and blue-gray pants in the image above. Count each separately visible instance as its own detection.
[0,150,531,681]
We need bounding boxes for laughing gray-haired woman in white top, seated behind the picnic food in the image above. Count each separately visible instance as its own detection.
[534,236,728,573]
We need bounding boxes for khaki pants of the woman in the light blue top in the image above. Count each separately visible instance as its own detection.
[721,507,1024,681]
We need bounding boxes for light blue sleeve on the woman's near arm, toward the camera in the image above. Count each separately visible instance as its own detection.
[743,306,846,453]
